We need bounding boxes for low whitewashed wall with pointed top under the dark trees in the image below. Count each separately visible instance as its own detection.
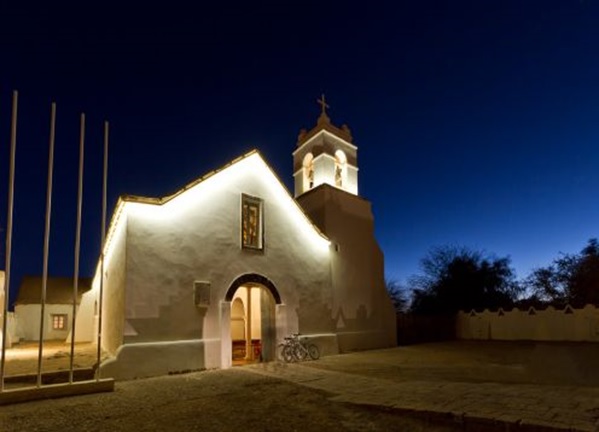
[456,305,599,342]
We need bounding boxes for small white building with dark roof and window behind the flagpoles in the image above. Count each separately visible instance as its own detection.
[13,276,91,342]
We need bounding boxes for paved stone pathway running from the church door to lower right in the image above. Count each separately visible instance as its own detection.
[244,362,599,432]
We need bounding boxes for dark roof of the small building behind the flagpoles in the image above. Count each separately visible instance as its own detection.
[15,276,92,305]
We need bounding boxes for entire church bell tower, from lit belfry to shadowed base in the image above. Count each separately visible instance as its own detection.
[293,96,397,352]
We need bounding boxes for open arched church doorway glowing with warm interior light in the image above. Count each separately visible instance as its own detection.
[221,273,281,367]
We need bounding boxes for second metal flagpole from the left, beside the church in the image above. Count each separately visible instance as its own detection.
[37,102,56,387]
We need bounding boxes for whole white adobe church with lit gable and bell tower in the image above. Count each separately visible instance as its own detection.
[75,99,396,379]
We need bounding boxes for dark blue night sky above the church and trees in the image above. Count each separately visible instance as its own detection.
[0,0,599,298]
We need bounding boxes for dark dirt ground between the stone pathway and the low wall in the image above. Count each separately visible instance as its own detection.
[307,341,599,387]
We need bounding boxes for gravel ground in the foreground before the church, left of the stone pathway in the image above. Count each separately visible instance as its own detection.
[0,368,461,432]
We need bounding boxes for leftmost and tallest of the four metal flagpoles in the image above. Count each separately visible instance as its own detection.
[0,90,19,391]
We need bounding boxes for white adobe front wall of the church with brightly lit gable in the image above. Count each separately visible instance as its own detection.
[102,154,336,378]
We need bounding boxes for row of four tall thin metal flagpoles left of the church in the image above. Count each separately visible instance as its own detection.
[0,91,108,392]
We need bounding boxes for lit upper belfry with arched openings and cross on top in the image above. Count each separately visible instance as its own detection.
[293,95,358,198]
